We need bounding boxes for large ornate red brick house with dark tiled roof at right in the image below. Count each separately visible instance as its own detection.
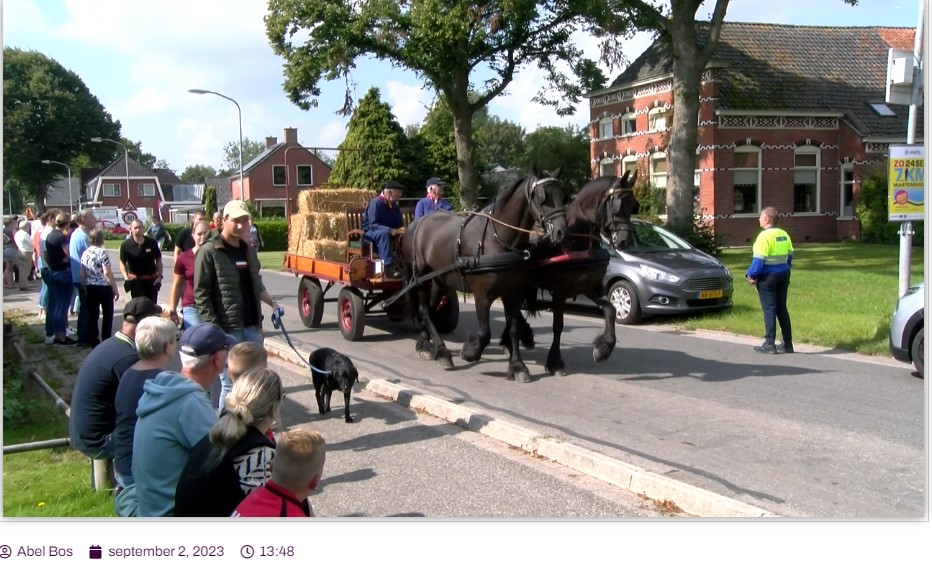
[587,22,923,245]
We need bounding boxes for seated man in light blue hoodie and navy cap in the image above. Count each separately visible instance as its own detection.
[132,322,236,516]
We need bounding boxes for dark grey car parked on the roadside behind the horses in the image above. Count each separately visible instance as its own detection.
[603,220,734,325]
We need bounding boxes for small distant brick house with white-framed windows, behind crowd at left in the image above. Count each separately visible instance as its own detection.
[84,156,165,228]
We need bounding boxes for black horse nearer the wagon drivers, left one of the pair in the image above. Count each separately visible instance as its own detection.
[401,167,566,382]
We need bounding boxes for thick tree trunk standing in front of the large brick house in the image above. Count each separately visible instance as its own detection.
[667,21,702,230]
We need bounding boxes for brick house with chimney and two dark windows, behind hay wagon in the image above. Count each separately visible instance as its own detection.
[231,128,330,217]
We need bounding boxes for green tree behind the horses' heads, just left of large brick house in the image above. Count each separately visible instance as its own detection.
[519,126,591,192]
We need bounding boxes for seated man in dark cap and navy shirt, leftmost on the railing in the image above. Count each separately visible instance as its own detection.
[68,297,162,459]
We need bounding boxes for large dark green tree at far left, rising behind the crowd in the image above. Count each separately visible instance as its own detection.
[3,47,120,203]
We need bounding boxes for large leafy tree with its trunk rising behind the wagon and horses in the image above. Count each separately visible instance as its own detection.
[265,0,610,208]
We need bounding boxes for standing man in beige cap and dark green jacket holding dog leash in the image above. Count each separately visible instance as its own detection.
[194,200,279,408]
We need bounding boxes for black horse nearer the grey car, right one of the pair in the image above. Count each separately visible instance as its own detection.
[501,171,638,375]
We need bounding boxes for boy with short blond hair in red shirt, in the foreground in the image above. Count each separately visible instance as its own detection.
[232,428,327,518]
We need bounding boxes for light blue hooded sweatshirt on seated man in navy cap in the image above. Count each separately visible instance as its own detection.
[133,371,217,516]
